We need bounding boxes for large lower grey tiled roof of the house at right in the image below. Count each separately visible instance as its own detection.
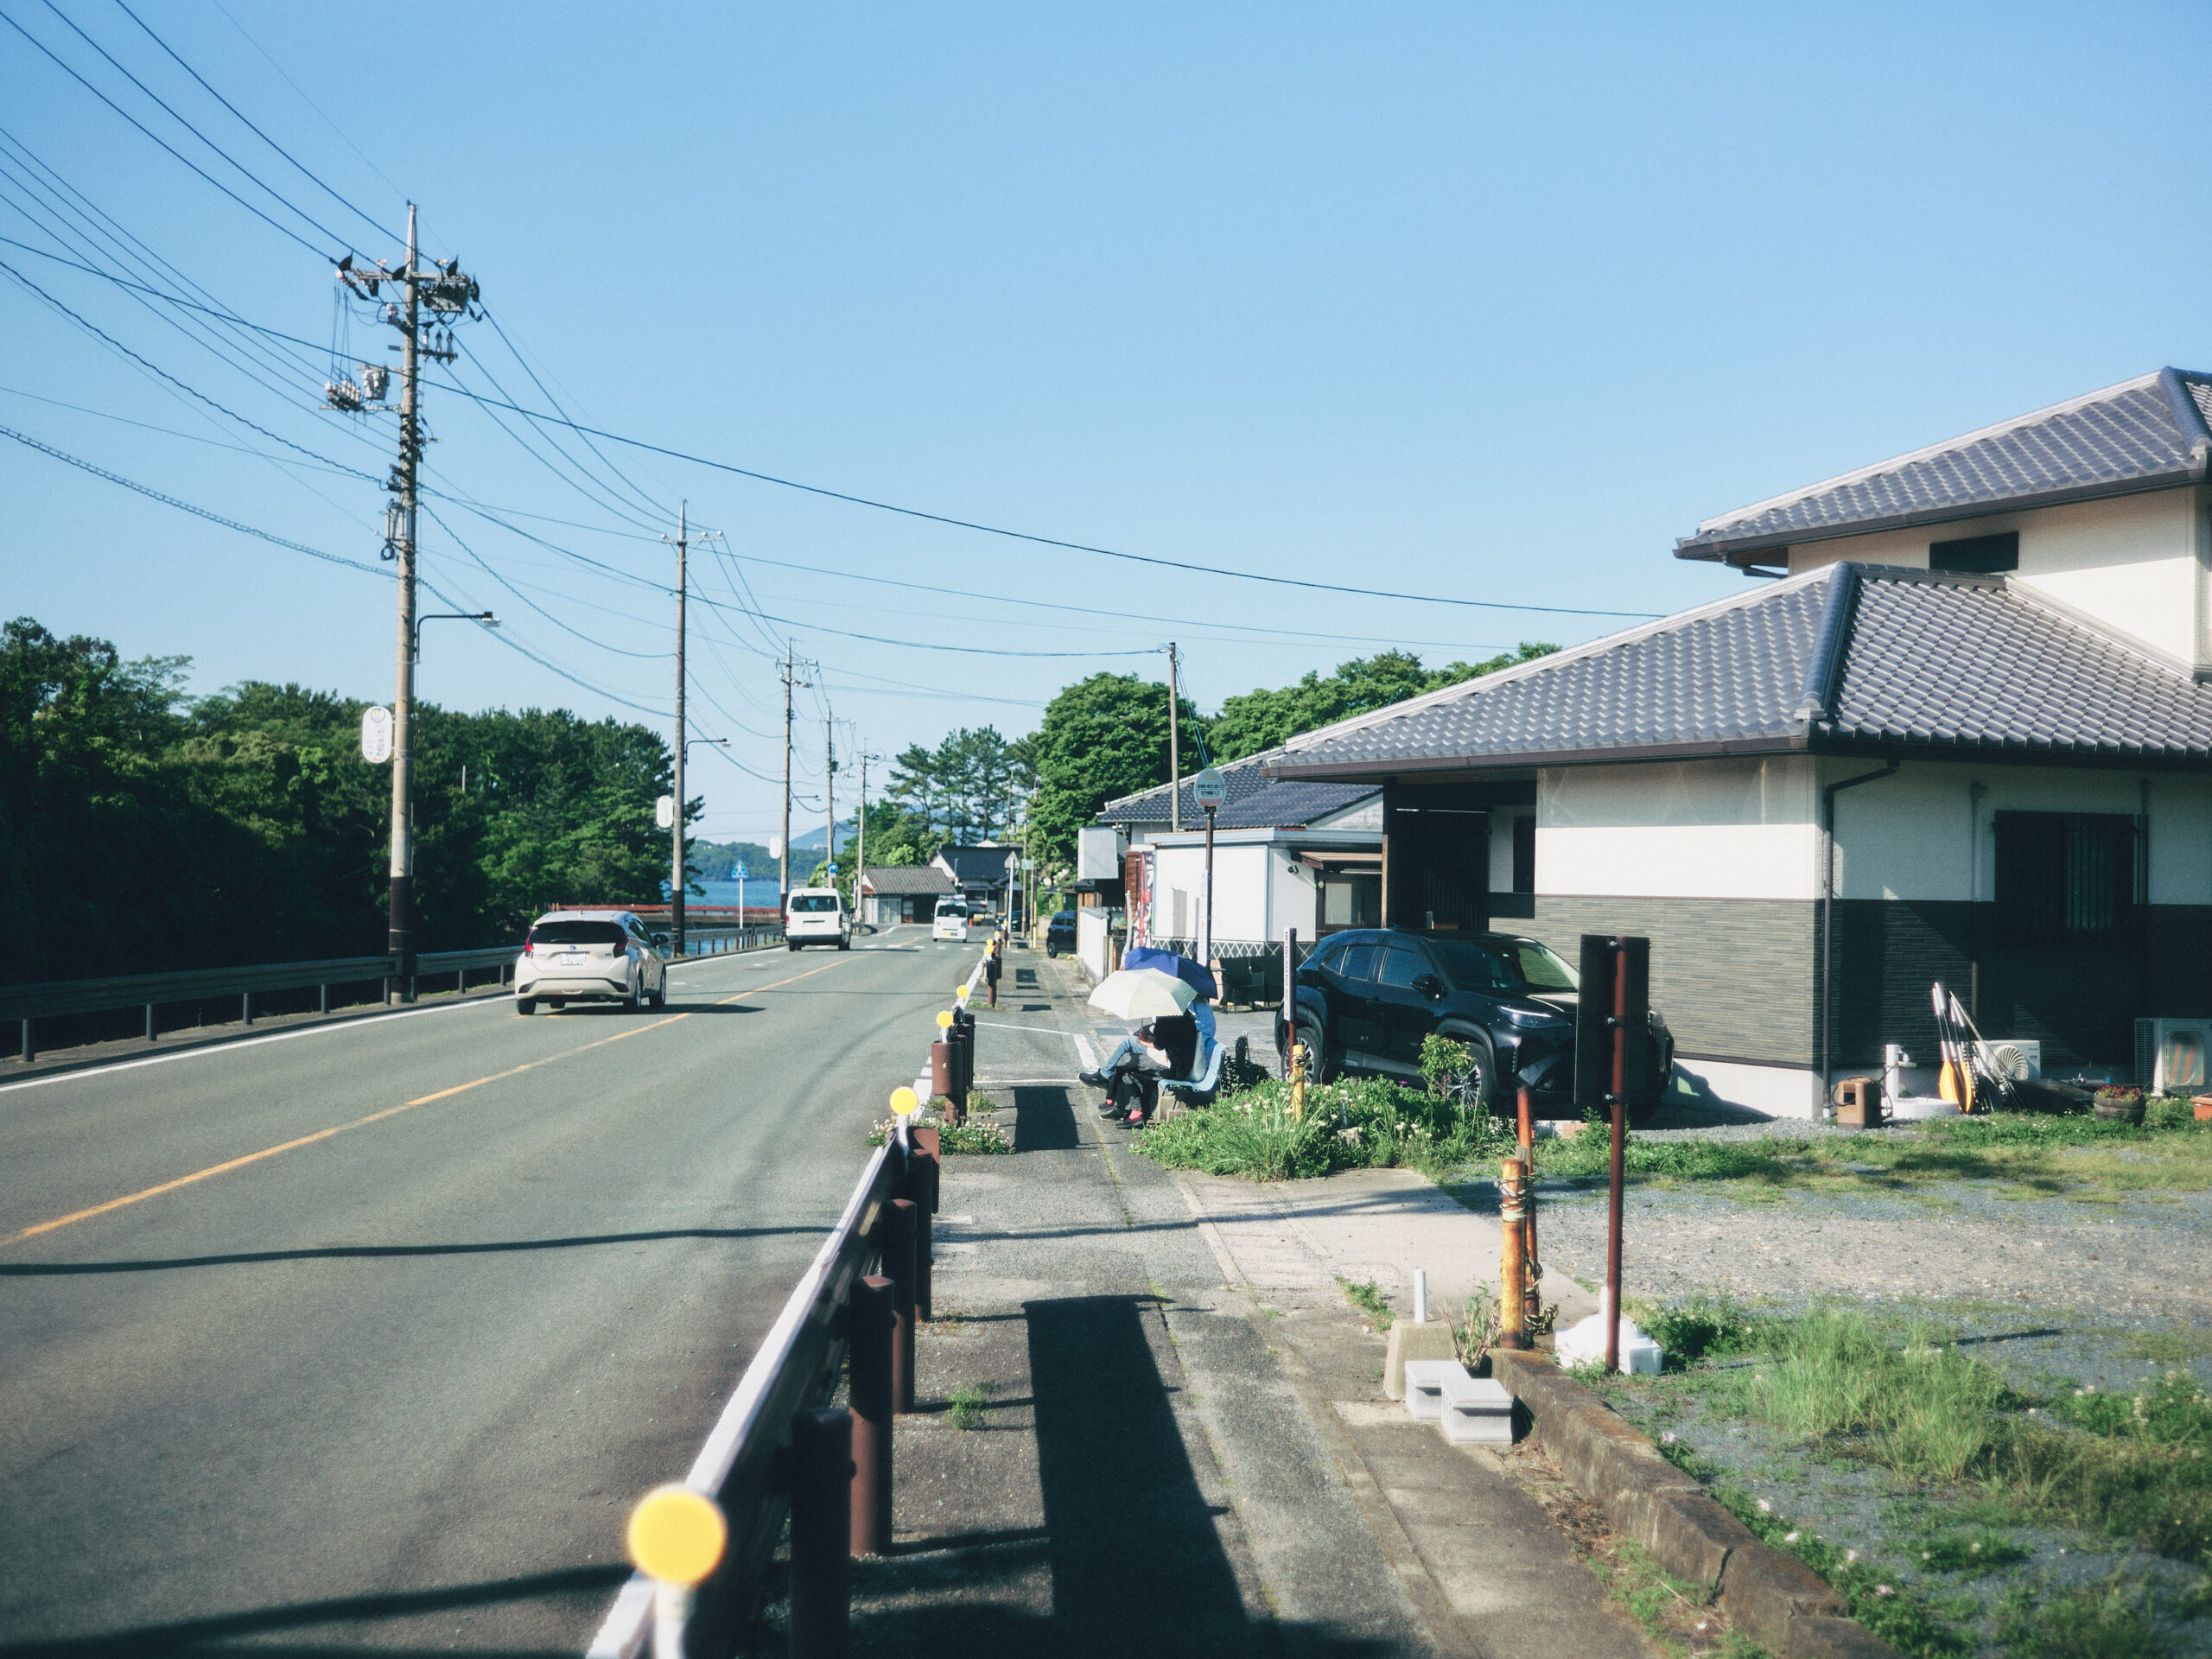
[1272,564,2212,779]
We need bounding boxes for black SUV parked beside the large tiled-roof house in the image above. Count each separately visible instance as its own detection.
[1276,927,1675,1117]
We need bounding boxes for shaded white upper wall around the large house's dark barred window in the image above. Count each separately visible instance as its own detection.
[1816,759,2212,905]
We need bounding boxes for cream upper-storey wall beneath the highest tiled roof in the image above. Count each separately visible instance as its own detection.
[1789,489,2212,664]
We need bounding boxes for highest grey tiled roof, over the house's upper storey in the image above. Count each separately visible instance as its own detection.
[1675,370,2212,560]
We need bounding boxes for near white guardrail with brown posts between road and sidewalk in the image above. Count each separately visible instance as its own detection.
[588,1141,907,1659]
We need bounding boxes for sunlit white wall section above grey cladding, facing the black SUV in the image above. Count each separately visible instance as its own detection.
[1530,757,1821,898]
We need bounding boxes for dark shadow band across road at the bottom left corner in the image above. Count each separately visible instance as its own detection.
[0,1564,631,1659]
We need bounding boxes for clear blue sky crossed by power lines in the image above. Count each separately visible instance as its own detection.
[0,0,2212,836]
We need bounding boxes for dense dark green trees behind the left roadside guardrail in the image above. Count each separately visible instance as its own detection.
[0,617,677,982]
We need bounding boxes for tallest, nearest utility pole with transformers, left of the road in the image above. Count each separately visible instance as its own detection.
[323,201,478,1002]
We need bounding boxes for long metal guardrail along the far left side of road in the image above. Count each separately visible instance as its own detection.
[0,925,783,1059]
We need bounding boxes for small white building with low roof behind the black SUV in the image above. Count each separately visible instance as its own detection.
[1099,750,1382,960]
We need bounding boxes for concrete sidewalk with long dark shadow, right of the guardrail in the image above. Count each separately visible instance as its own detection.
[831,949,1655,1659]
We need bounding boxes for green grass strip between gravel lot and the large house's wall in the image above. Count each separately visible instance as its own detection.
[1537,1102,2212,1199]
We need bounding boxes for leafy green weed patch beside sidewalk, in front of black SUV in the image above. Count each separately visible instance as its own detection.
[1133,1077,1510,1181]
